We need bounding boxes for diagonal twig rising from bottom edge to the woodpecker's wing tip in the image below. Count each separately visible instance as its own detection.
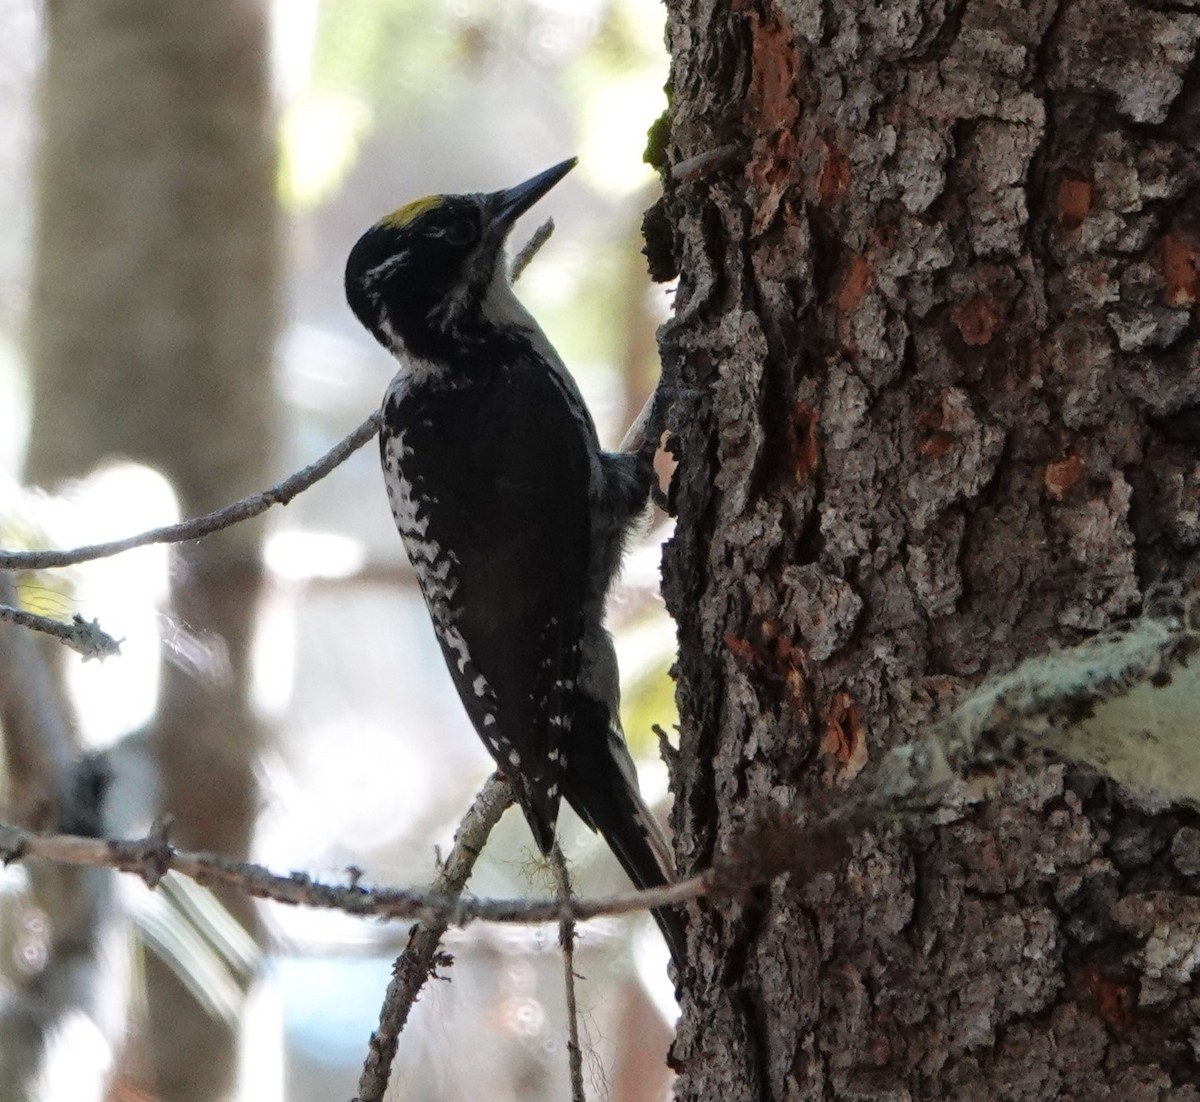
[356,773,512,1102]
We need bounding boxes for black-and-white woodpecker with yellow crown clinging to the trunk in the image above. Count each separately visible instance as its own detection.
[346,158,685,970]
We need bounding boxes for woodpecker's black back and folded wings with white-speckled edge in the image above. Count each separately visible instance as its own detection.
[383,365,590,852]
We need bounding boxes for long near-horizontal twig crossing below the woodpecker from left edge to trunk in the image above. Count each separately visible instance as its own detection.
[0,822,716,926]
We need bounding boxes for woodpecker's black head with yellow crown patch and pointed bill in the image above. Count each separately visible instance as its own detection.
[346,157,575,364]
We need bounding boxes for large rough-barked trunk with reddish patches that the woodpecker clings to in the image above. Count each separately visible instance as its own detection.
[649,0,1200,1102]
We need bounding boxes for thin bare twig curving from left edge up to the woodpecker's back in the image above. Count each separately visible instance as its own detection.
[0,412,382,570]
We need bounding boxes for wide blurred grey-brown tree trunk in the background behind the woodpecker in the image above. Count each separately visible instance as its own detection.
[28,0,278,1100]
